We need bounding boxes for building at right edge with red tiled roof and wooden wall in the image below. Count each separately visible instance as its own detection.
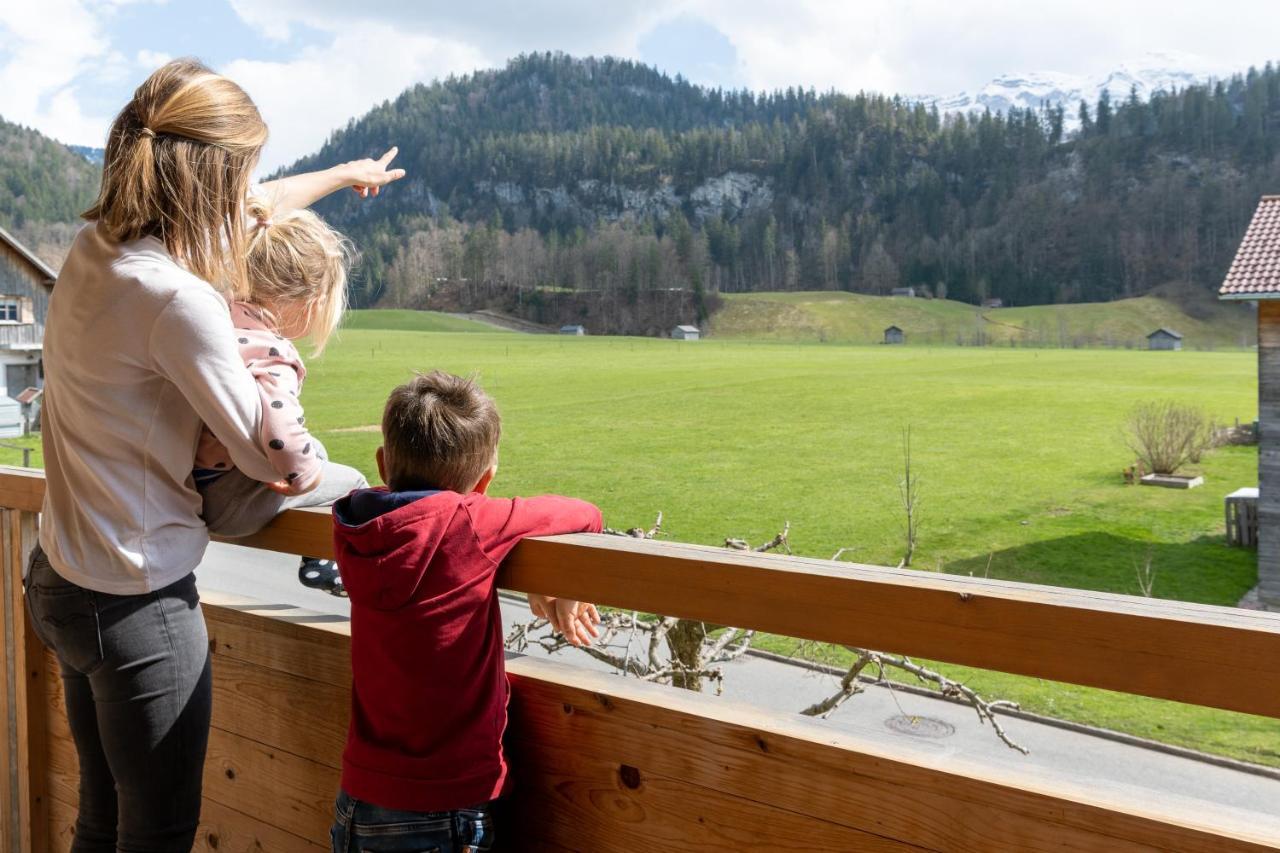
[1219,196,1280,610]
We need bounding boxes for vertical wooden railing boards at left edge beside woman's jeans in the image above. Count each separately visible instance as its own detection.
[0,510,49,853]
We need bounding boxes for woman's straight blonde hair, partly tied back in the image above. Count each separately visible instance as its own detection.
[83,59,266,297]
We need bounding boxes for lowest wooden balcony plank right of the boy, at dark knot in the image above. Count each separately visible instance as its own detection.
[509,740,920,853]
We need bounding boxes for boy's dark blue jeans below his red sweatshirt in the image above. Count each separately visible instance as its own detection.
[330,792,493,853]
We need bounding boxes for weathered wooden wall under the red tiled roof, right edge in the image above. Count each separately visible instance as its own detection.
[1258,300,1280,610]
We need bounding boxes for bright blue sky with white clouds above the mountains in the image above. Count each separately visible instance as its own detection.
[0,0,1280,172]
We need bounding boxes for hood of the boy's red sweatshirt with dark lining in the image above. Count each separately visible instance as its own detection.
[333,488,466,610]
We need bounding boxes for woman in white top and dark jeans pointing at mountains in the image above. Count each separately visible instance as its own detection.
[27,60,403,853]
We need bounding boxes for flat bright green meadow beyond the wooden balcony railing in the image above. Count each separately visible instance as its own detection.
[0,311,1280,766]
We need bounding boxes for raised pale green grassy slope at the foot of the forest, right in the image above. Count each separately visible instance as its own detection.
[710,291,1256,350]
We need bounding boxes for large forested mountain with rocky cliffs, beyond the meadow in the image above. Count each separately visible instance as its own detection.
[275,54,1280,320]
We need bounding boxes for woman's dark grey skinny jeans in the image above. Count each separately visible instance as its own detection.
[24,547,212,853]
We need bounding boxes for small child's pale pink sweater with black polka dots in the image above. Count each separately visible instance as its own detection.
[196,302,324,487]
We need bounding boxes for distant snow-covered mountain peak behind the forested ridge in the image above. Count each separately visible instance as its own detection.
[911,53,1230,131]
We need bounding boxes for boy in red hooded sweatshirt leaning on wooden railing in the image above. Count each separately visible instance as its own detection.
[333,371,600,853]
